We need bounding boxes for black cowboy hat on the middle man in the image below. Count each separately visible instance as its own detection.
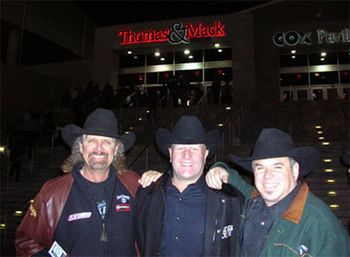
[156,115,220,157]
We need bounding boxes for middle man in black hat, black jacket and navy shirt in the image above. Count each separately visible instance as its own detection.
[136,116,243,257]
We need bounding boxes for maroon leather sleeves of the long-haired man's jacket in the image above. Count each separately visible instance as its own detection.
[15,171,139,256]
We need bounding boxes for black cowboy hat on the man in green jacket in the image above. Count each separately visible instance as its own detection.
[230,128,320,178]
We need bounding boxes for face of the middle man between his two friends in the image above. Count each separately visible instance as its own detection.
[169,144,208,185]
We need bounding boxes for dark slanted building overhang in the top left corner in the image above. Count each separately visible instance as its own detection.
[1,0,96,58]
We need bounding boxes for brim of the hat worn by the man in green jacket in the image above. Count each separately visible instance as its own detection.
[229,146,320,178]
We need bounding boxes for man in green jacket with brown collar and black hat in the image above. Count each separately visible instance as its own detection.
[206,128,350,257]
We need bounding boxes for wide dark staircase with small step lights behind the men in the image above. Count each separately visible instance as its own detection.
[0,99,350,256]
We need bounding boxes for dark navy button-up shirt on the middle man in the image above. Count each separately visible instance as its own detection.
[160,177,206,257]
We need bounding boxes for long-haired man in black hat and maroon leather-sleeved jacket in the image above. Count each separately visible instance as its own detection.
[16,108,138,256]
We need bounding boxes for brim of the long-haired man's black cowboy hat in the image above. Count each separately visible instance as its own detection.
[61,124,136,152]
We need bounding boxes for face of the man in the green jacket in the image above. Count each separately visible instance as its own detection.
[252,157,299,206]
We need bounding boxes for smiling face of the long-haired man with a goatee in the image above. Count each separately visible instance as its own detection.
[80,135,118,171]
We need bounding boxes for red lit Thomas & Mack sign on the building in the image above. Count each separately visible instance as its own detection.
[118,21,226,45]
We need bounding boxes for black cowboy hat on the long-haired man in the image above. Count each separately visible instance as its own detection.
[61,108,136,151]
